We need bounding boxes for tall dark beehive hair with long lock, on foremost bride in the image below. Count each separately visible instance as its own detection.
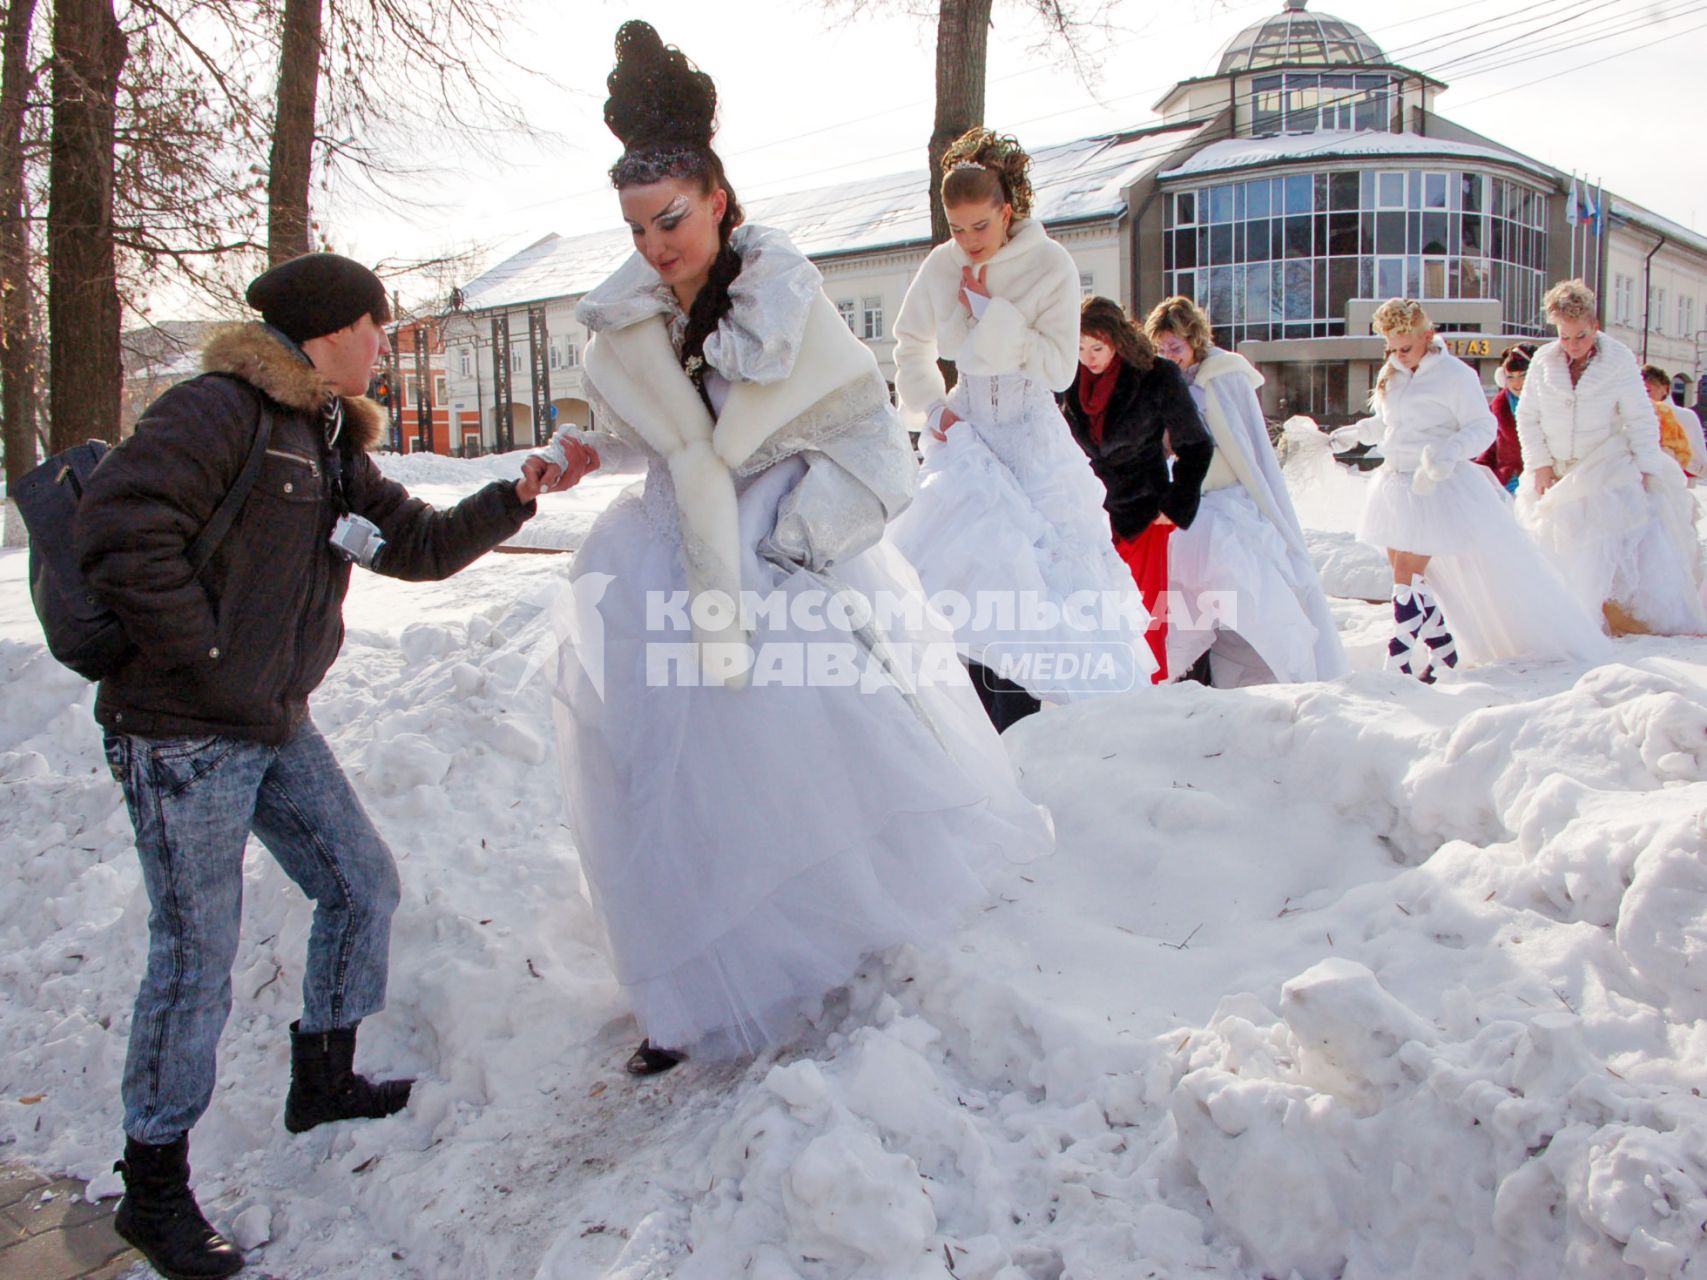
[604,19,744,384]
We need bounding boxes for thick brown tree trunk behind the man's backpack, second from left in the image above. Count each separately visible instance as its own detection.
[48,0,125,452]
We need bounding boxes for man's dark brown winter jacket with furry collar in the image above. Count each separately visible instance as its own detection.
[77,324,534,744]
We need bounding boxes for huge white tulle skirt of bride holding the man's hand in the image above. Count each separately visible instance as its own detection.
[553,459,1053,1056]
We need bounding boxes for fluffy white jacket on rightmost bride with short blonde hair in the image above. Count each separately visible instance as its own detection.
[1518,333,1681,486]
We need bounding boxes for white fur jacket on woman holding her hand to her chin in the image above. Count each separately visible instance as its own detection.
[894,218,1079,430]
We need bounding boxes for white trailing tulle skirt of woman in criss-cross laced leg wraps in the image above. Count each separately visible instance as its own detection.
[1359,463,1611,662]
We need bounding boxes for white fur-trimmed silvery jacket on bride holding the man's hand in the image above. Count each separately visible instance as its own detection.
[575,227,917,672]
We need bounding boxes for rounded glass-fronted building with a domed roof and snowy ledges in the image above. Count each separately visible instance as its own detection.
[1133,0,1594,422]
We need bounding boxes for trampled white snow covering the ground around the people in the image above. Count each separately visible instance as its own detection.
[0,440,1707,1280]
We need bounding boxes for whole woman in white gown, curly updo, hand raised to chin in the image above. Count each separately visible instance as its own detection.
[894,130,1157,729]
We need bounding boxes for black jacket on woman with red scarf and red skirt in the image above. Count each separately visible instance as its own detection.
[1062,357,1215,538]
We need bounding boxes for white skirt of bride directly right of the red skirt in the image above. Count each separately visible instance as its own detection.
[1168,485,1320,681]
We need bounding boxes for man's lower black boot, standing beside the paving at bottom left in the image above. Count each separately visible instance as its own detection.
[113,1133,242,1280]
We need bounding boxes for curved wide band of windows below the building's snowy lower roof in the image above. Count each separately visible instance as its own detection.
[1162,169,1547,346]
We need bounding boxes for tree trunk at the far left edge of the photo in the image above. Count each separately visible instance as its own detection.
[0,0,36,546]
